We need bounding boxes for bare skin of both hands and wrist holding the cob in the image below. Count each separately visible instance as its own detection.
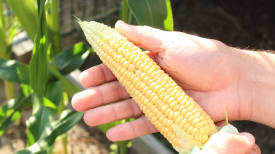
[69,21,275,154]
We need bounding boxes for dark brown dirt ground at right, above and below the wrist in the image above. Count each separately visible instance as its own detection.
[171,0,275,154]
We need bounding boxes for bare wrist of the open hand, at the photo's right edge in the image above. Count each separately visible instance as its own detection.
[237,50,275,128]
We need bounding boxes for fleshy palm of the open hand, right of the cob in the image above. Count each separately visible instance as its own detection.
[153,33,244,121]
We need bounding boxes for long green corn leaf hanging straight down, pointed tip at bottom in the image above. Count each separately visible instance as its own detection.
[30,0,50,98]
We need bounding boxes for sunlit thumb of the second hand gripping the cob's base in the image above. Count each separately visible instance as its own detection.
[201,133,255,154]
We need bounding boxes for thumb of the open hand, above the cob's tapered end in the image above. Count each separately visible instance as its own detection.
[115,20,170,52]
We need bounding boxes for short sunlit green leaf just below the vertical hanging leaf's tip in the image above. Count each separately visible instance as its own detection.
[26,94,54,146]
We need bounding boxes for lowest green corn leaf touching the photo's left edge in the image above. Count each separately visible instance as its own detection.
[0,86,30,136]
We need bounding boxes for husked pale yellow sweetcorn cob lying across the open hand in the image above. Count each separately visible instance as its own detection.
[79,21,217,150]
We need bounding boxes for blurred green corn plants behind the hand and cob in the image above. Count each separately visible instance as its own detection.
[0,0,173,154]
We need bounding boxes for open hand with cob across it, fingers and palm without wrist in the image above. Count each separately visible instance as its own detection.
[72,22,274,149]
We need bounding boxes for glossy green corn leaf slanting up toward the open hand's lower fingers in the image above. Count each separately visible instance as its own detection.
[17,110,83,154]
